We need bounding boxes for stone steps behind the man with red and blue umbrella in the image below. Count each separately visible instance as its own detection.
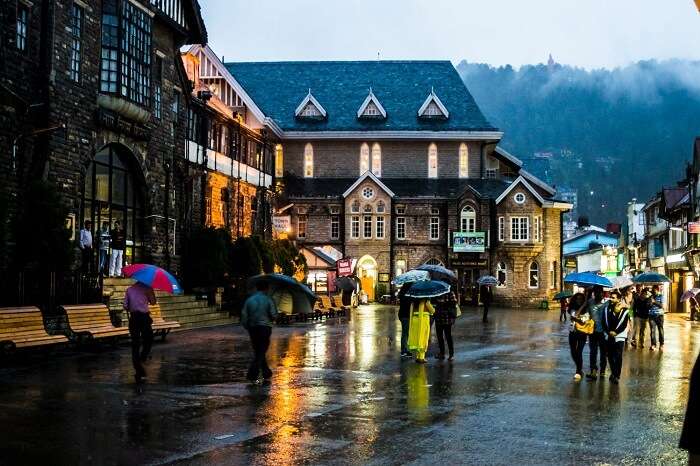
[102,278,237,330]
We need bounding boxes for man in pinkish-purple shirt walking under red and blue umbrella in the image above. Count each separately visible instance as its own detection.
[124,282,157,383]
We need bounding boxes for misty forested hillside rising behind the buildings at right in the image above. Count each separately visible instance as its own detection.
[457,60,700,224]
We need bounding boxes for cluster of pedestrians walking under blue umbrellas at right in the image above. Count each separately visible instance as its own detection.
[560,285,664,384]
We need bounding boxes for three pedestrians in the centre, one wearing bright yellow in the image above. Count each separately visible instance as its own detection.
[398,283,460,363]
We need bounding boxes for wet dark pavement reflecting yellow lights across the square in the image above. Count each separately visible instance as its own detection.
[0,306,700,465]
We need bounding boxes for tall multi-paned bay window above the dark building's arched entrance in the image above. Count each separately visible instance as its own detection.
[100,0,152,106]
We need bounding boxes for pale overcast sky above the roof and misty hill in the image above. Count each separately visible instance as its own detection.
[200,0,700,68]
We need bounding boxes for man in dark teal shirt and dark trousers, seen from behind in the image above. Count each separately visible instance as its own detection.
[241,280,277,383]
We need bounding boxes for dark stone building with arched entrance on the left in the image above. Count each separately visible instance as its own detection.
[0,0,207,270]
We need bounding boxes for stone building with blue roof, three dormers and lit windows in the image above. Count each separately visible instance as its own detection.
[225,61,571,305]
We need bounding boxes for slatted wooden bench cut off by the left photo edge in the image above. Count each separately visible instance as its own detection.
[0,307,68,350]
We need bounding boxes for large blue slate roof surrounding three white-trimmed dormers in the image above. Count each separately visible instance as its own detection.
[225,60,501,135]
